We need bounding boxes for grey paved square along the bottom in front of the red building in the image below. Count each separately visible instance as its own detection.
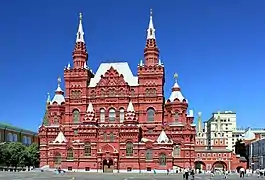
[0,172,257,180]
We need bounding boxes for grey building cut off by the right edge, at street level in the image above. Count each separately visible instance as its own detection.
[246,138,265,170]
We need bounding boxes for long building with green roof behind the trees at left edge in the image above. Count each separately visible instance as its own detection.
[0,123,38,145]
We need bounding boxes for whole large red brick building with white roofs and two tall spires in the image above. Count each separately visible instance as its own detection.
[39,10,245,172]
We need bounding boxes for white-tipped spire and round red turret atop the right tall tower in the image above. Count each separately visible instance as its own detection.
[144,9,159,66]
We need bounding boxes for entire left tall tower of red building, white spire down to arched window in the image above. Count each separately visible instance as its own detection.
[64,13,94,123]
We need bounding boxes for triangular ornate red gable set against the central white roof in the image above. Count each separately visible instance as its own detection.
[97,66,128,86]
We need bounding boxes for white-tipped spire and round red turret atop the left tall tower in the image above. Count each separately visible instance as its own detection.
[73,13,88,69]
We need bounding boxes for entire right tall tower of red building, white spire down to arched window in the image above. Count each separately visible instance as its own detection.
[137,10,165,126]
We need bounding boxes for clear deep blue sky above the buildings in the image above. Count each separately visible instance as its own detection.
[0,0,265,131]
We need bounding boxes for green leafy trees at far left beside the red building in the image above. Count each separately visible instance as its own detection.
[0,142,39,167]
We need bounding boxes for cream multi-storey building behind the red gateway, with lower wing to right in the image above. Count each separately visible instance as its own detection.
[205,111,265,152]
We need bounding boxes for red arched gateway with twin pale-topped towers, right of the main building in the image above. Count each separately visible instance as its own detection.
[195,113,244,171]
